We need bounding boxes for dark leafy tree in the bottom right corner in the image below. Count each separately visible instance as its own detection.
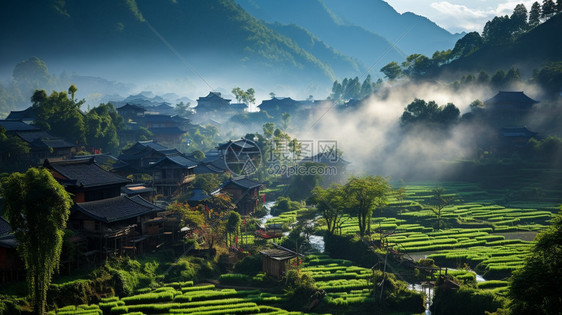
[509,212,562,314]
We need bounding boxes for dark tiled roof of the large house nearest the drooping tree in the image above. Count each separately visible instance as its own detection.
[71,196,164,223]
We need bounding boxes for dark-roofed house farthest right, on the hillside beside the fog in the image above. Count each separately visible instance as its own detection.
[484,91,538,127]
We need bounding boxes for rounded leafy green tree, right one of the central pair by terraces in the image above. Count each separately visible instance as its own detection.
[343,176,390,237]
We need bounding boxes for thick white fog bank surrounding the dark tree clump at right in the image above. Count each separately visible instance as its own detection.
[294,83,493,180]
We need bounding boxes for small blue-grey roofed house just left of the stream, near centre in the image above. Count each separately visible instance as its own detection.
[219,178,263,215]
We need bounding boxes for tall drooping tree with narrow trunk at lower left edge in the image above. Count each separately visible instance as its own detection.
[1,168,72,314]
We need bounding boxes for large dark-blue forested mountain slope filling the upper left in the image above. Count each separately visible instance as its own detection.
[0,0,353,96]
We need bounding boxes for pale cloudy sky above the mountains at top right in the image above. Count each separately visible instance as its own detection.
[385,0,532,33]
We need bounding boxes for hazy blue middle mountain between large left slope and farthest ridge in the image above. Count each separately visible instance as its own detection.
[237,0,405,76]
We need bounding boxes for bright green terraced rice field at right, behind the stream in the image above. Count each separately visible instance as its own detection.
[318,183,562,279]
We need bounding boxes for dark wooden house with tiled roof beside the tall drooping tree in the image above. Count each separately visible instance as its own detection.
[69,196,164,256]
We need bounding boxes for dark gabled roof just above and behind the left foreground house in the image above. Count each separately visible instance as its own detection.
[44,158,130,188]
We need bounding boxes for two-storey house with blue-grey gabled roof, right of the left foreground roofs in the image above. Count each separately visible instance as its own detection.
[150,154,197,197]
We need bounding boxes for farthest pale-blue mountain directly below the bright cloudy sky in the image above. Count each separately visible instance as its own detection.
[323,0,464,57]
